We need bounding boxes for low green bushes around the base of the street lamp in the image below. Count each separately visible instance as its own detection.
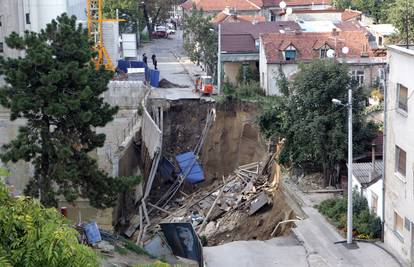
[317,191,381,239]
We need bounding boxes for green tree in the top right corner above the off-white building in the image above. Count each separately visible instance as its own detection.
[389,0,414,48]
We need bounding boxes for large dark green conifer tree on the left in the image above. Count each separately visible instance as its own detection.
[0,14,133,208]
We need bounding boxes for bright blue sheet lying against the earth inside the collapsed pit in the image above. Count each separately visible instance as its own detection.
[175,151,204,184]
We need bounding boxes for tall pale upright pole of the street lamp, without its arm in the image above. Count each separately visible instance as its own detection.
[346,86,352,244]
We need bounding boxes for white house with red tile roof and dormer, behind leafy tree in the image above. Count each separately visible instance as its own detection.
[259,21,386,95]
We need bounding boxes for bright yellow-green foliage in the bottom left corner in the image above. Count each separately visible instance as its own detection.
[0,183,99,267]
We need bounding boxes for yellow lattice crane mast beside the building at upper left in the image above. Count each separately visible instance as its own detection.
[86,0,116,71]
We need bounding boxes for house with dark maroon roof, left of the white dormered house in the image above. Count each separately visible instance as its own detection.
[221,21,300,84]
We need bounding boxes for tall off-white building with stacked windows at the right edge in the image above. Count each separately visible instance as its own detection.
[384,45,414,266]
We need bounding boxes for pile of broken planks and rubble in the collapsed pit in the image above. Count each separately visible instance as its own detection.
[149,158,277,245]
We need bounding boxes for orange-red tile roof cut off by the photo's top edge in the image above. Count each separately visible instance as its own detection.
[181,0,263,11]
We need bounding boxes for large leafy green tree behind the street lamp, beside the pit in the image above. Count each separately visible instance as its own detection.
[259,61,375,184]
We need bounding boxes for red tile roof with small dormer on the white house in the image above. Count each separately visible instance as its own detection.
[262,31,373,63]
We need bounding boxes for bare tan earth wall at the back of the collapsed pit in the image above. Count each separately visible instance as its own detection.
[201,101,267,179]
